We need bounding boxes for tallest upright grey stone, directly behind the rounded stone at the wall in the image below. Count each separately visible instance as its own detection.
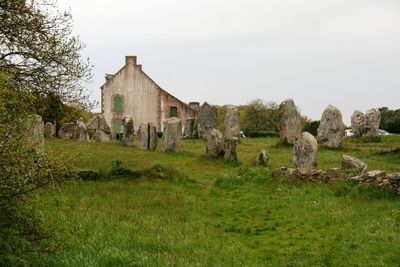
[278,99,301,144]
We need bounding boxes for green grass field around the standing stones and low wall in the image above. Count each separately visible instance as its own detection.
[30,135,400,266]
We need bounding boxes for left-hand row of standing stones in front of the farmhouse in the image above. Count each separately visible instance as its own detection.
[29,102,240,161]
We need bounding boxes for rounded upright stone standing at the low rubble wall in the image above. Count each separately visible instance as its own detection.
[293,132,318,168]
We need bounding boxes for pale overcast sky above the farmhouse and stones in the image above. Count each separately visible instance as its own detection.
[59,0,400,124]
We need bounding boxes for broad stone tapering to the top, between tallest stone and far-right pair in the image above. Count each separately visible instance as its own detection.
[317,105,346,148]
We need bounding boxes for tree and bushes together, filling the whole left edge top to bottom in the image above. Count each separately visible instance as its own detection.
[0,0,93,266]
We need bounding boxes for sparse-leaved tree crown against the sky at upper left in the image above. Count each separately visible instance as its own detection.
[0,0,93,108]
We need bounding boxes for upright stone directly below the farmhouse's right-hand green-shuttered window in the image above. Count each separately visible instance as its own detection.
[162,118,182,151]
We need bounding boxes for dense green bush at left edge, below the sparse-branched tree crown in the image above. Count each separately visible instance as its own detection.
[0,73,73,266]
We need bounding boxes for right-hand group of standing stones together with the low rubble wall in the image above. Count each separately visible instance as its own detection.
[273,99,400,194]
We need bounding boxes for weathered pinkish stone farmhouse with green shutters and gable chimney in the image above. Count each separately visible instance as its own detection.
[101,56,199,136]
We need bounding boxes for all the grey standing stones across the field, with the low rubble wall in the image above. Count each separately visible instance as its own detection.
[28,99,400,193]
